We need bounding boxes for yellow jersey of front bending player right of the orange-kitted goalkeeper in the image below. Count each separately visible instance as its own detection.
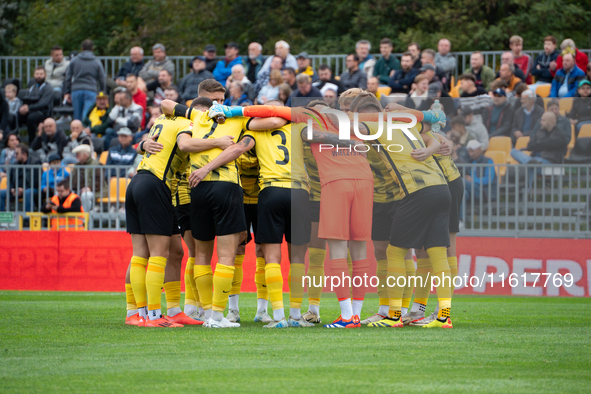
[362,122,447,200]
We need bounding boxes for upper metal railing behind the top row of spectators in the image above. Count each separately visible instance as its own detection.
[0,49,591,86]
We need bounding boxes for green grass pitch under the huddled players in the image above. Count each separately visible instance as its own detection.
[0,292,591,393]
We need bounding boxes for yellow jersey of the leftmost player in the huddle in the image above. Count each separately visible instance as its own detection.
[137,115,193,191]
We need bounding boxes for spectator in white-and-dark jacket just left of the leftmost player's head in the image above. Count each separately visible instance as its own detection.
[103,89,143,150]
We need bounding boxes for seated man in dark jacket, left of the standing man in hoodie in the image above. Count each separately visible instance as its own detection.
[18,66,53,144]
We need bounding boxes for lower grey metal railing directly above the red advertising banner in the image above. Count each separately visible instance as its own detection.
[0,164,591,238]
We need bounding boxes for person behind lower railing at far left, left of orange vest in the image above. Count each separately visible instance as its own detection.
[0,144,41,212]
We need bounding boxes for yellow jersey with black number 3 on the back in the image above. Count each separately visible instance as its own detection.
[243,123,310,191]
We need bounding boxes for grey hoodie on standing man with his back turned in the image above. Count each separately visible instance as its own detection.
[63,51,106,93]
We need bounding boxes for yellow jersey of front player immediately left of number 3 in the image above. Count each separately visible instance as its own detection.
[190,110,251,185]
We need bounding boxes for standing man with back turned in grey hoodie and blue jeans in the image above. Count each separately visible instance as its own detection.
[64,39,107,120]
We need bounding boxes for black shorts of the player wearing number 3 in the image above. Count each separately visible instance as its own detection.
[255,187,312,245]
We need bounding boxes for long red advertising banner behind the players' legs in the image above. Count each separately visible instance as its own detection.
[0,231,591,297]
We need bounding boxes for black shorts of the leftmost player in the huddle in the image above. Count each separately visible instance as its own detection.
[125,171,179,237]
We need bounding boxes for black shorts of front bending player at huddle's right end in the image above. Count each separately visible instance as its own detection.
[390,185,451,250]
